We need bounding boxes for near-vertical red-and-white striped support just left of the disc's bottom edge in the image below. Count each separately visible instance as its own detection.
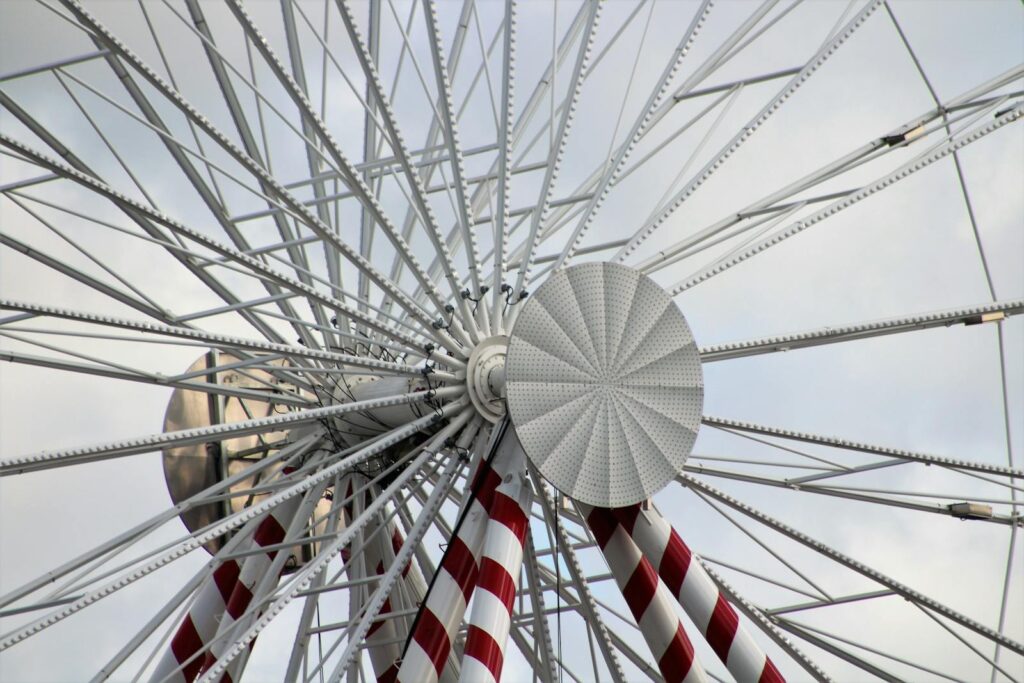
[459,429,532,683]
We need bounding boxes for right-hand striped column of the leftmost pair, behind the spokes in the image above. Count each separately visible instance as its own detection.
[200,489,302,683]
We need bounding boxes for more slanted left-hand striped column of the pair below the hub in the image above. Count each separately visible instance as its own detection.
[397,461,501,683]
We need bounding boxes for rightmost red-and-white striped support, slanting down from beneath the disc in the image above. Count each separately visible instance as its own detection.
[610,505,785,683]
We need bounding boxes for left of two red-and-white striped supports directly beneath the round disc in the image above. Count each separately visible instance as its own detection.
[580,505,708,683]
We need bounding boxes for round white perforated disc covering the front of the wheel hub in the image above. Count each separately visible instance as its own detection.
[506,263,703,507]
